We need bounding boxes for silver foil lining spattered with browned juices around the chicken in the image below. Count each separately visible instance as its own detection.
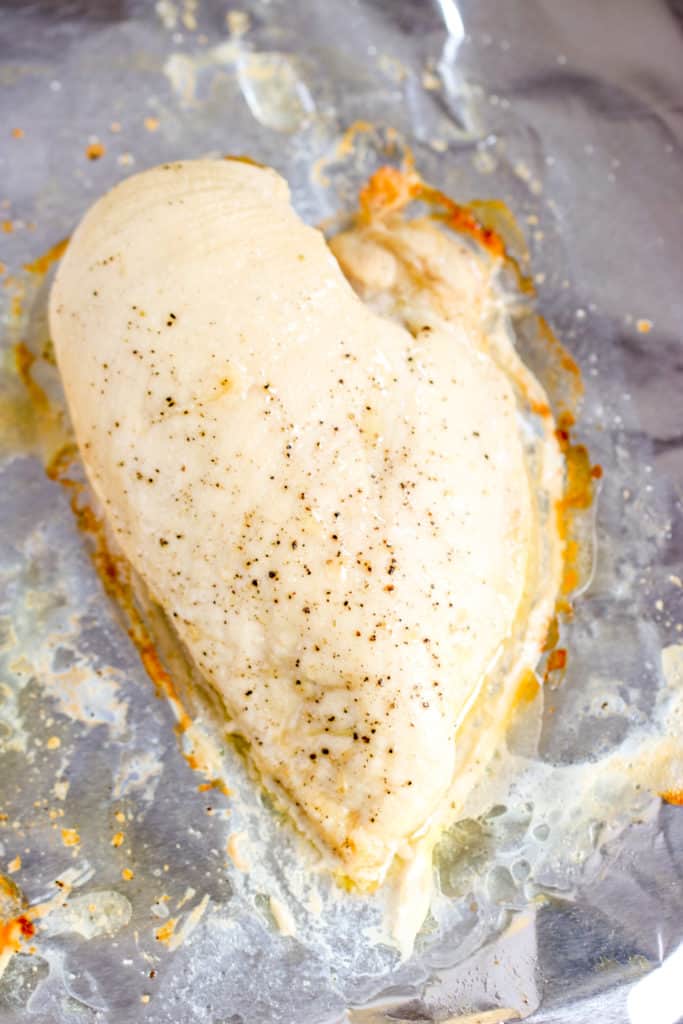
[0,0,683,1024]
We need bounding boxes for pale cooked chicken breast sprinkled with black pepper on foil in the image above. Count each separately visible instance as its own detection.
[50,161,561,888]
